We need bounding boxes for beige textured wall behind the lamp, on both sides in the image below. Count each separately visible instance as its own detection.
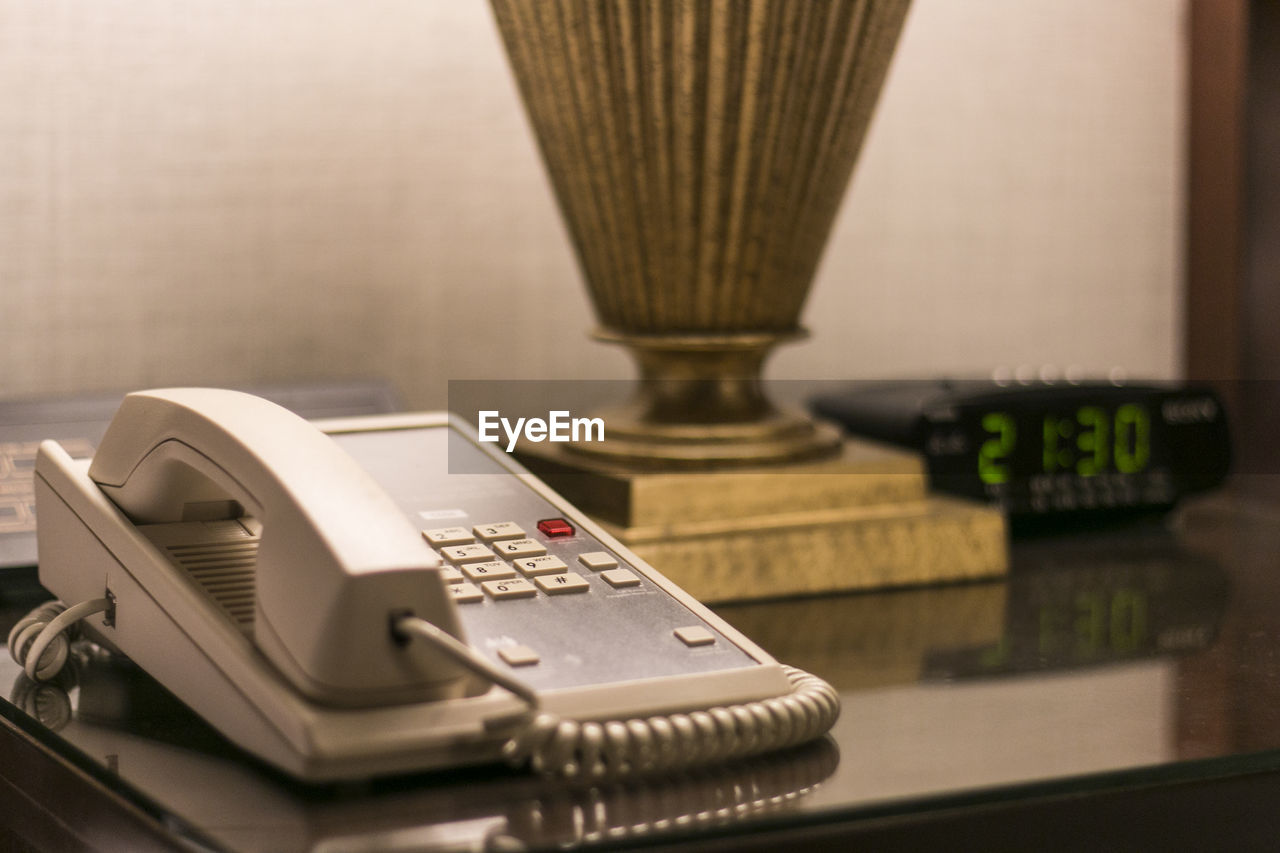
[0,0,1185,406]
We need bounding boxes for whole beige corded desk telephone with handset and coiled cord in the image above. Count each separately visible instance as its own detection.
[20,388,838,780]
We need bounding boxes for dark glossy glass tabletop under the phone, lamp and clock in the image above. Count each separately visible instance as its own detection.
[0,488,1280,850]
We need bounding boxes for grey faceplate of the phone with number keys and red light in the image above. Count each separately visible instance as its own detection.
[334,425,754,689]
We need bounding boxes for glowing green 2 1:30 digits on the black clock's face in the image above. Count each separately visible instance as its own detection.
[978,402,1151,485]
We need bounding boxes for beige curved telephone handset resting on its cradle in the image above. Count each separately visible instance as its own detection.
[88,388,462,706]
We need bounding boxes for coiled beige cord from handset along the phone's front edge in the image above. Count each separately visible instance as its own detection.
[392,616,840,780]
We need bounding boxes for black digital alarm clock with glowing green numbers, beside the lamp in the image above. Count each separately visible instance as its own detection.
[812,380,1231,517]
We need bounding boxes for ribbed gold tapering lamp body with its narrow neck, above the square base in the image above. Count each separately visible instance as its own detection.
[492,0,909,466]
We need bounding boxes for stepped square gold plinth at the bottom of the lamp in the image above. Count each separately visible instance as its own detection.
[518,441,1007,601]
